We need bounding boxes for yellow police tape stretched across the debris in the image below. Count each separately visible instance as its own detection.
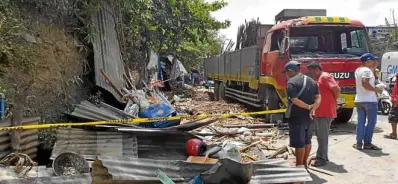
[0,109,286,131]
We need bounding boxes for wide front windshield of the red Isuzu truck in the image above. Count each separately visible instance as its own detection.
[289,25,369,58]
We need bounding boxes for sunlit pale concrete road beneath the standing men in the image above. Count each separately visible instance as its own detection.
[308,111,398,184]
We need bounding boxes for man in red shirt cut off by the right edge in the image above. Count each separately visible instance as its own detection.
[384,74,398,139]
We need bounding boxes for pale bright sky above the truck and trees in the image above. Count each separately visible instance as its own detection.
[206,0,398,40]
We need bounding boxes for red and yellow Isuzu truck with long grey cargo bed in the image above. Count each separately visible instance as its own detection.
[204,10,369,122]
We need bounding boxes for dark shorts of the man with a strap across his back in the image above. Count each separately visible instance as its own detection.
[288,117,314,148]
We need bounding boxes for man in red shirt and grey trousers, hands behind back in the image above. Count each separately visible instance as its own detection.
[308,62,340,167]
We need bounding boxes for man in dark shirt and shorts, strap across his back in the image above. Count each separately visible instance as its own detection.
[285,61,321,168]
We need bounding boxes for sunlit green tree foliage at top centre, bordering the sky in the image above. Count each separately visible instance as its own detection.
[121,0,230,67]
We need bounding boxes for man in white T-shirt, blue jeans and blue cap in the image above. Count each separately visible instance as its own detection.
[353,53,381,150]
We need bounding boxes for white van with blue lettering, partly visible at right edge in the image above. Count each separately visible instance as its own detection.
[380,52,398,84]
